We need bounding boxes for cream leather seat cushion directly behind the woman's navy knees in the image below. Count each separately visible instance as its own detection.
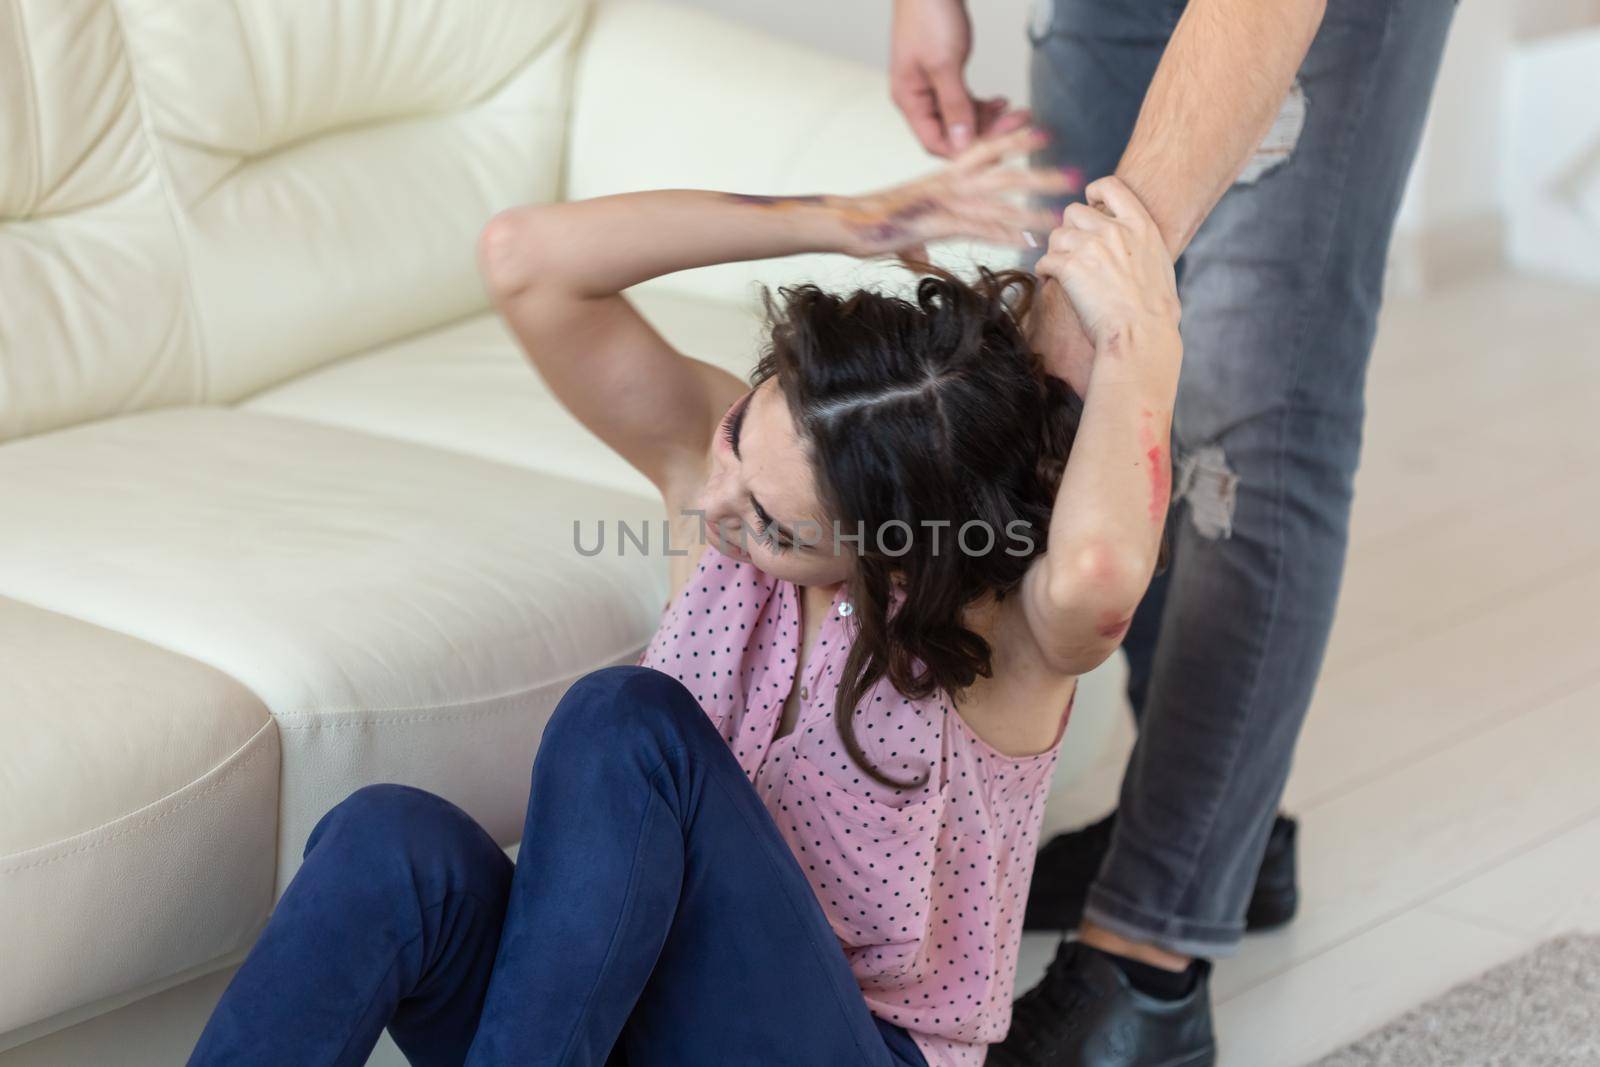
[0,400,666,883]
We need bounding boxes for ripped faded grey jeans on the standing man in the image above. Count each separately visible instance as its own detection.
[1030,0,1454,957]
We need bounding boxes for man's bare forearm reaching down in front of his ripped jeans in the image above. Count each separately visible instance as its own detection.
[1117,0,1325,258]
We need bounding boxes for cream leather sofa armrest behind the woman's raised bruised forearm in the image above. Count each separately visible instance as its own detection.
[563,0,1016,310]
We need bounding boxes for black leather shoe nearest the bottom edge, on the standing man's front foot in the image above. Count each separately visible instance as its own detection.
[984,941,1216,1067]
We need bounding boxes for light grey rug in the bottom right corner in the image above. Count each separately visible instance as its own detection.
[1315,934,1600,1067]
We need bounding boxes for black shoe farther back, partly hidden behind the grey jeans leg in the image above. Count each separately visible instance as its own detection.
[1022,811,1299,933]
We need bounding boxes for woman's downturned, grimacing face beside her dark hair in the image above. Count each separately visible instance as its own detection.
[699,379,853,585]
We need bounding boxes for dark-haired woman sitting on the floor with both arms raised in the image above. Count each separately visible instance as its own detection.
[192,130,1181,1067]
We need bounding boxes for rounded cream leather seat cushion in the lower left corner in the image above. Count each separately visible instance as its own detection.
[0,598,278,1033]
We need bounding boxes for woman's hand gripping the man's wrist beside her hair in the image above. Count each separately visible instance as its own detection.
[1035,178,1178,352]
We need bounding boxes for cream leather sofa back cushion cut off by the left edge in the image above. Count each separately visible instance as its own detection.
[0,0,205,442]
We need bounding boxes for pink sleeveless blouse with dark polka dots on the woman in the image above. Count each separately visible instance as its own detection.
[640,545,1072,1067]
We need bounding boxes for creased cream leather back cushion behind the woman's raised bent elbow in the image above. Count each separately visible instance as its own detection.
[114,0,587,402]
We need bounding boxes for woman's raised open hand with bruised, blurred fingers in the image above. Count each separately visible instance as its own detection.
[838,126,1075,259]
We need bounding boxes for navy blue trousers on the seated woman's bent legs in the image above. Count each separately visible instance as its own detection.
[189,667,926,1067]
